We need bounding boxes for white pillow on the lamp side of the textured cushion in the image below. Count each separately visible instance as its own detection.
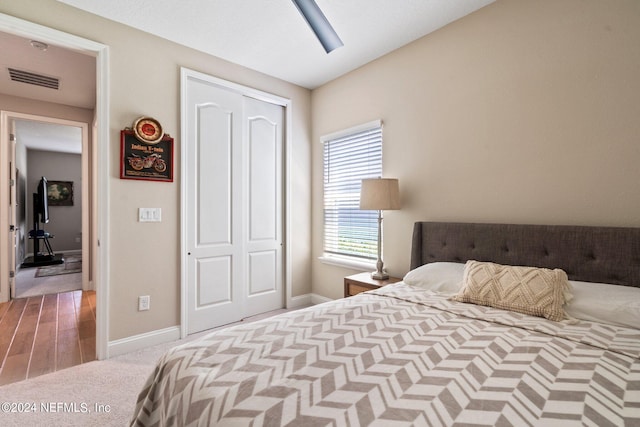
[402,262,464,296]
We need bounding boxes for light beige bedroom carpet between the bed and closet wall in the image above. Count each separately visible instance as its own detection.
[0,309,302,427]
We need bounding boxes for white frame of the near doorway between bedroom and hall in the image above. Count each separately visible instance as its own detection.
[0,13,110,360]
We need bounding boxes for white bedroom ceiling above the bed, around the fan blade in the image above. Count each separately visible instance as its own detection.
[58,0,494,89]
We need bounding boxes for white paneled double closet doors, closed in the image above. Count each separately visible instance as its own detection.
[183,72,284,334]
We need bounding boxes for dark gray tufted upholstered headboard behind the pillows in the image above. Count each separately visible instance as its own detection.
[411,222,640,287]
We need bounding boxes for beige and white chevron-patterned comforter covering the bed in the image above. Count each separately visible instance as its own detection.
[132,283,640,427]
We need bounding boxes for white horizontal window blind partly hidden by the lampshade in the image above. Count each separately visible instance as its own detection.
[323,121,382,260]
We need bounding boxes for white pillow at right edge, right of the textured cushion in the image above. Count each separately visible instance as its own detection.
[564,280,640,329]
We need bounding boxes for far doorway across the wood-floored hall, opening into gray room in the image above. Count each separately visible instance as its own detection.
[8,113,93,298]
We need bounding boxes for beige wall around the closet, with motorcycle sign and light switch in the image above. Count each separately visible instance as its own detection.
[0,0,311,341]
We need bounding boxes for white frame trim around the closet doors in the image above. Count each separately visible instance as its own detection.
[180,67,293,338]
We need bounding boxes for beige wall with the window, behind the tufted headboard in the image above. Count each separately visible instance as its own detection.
[312,0,640,298]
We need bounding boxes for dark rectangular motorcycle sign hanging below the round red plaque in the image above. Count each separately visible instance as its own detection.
[120,129,173,182]
